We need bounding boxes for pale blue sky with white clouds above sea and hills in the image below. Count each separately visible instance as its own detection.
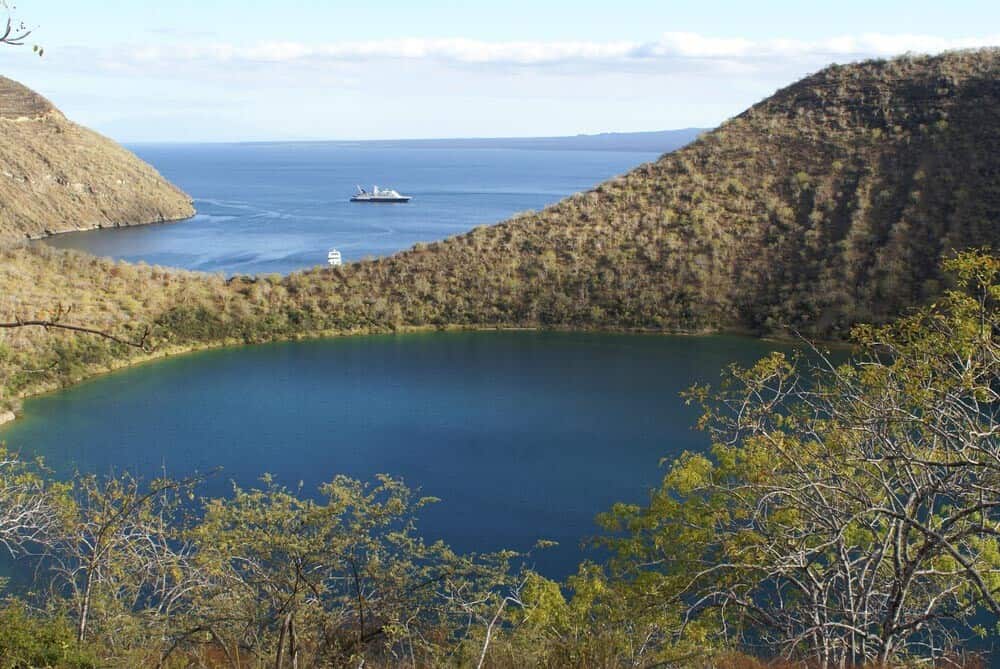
[0,0,1000,142]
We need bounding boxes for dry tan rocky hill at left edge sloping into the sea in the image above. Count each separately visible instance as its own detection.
[0,77,194,244]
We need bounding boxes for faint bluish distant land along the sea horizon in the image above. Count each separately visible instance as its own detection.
[292,128,707,153]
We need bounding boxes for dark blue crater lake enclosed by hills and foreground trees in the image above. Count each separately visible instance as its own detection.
[0,332,790,577]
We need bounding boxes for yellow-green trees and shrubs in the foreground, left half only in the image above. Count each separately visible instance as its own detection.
[0,459,538,667]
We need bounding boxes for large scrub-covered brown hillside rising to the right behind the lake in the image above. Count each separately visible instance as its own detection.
[338,49,1000,336]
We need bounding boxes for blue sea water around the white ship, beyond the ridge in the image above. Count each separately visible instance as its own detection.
[46,143,657,275]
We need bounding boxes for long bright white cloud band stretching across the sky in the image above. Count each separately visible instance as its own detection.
[15,32,1000,87]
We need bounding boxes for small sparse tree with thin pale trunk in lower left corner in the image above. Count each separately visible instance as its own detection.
[43,474,205,653]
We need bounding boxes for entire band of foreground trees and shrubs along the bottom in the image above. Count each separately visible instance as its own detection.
[0,253,1000,669]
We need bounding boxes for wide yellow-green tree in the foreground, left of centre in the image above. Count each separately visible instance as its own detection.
[189,476,536,669]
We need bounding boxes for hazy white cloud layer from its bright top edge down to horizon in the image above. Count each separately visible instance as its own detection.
[0,33,1000,140]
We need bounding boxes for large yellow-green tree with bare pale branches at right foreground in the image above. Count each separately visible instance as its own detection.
[605,252,1000,667]
